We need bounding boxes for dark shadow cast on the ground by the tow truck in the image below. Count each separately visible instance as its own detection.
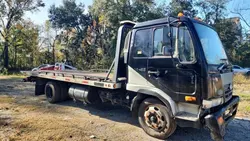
[58,101,250,141]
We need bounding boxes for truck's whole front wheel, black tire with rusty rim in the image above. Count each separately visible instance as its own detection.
[138,98,176,139]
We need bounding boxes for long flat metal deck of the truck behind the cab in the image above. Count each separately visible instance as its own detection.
[23,70,122,89]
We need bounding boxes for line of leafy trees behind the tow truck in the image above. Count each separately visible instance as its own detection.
[0,0,250,69]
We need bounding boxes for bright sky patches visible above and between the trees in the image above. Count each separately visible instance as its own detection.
[25,0,250,28]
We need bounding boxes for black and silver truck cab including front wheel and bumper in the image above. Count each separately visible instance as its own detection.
[116,16,239,140]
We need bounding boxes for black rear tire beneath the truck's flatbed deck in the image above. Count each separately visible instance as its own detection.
[44,82,61,103]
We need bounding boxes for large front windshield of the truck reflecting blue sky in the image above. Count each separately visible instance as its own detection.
[194,23,227,64]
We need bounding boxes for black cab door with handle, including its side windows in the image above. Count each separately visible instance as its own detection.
[147,25,197,101]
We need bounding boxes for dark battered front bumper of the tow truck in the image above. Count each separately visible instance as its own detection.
[205,96,240,137]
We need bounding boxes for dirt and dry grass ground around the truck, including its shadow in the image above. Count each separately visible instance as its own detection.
[0,77,250,141]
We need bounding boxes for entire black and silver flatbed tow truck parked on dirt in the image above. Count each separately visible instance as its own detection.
[26,15,239,140]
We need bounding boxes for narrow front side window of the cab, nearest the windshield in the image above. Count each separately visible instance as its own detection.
[177,26,195,63]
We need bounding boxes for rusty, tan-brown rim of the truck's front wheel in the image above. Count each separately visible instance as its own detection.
[144,106,167,132]
